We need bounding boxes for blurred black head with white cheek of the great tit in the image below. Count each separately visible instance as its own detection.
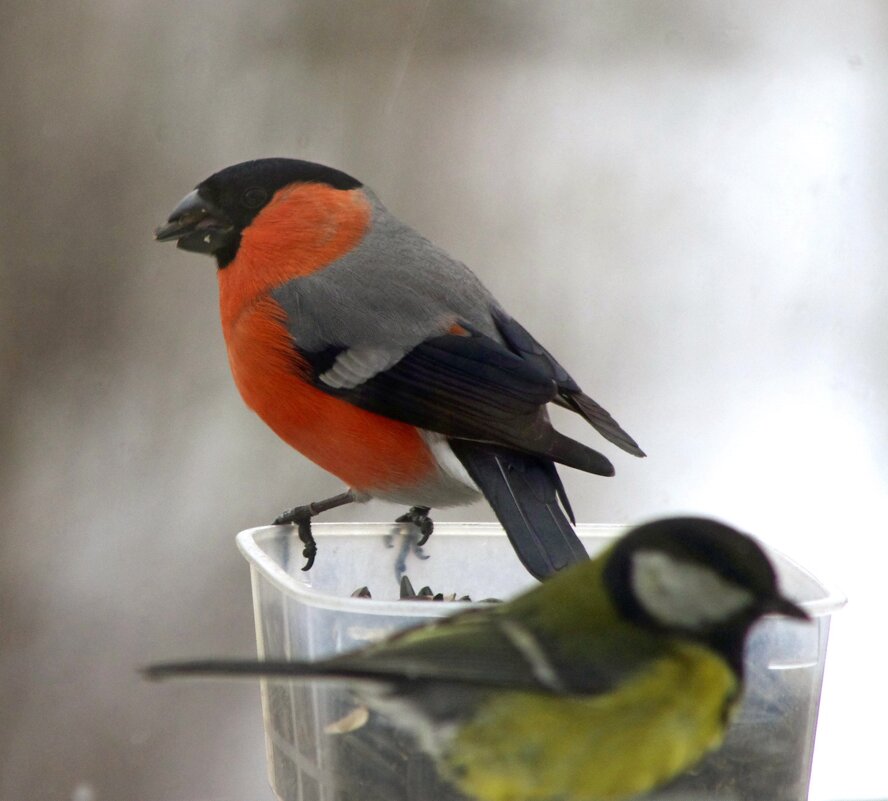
[604,517,808,673]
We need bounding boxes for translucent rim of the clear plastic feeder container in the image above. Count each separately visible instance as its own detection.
[235,522,848,617]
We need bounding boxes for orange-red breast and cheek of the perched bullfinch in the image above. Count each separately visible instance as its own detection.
[218,184,435,494]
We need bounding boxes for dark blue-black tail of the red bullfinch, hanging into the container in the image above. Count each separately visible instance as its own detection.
[450,440,588,580]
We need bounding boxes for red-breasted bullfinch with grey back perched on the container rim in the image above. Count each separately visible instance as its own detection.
[155,158,644,578]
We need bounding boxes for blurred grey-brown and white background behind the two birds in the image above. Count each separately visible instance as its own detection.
[0,0,888,801]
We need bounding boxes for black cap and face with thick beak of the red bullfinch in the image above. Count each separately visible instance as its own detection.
[154,158,361,267]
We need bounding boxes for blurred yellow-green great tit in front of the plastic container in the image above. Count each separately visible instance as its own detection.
[145,517,808,801]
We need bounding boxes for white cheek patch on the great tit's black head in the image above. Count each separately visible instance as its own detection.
[630,551,754,629]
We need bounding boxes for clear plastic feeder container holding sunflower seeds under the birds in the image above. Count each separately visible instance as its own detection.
[238,523,845,801]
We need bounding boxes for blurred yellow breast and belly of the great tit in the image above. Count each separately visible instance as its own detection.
[445,644,738,801]
